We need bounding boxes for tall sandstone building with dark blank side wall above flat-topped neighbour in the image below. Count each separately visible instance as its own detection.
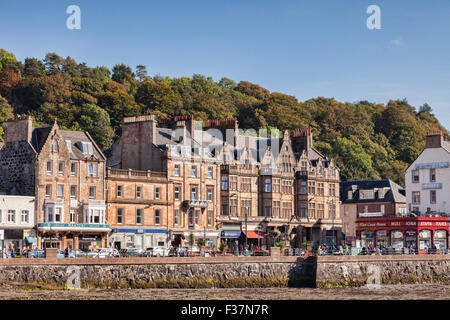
[108,116,220,247]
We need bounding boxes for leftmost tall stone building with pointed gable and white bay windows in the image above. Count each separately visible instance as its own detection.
[0,118,109,250]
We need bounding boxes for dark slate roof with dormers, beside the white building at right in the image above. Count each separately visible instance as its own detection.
[339,179,406,204]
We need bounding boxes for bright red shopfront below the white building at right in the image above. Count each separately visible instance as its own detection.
[356,217,449,253]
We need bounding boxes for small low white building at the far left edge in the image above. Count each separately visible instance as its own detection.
[0,195,36,249]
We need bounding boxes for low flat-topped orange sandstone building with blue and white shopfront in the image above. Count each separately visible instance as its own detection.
[106,168,173,250]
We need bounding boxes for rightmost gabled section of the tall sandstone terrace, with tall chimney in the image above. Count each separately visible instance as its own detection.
[292,128,342,246]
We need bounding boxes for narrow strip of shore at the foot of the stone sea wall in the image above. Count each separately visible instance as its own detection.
[0,284,450,300]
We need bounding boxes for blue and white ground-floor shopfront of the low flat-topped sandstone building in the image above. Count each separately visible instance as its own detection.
[108,228,169,250]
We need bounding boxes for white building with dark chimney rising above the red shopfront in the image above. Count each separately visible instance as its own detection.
[405,133,450,215]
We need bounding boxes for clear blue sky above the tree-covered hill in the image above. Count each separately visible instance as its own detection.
[0,0,450,128]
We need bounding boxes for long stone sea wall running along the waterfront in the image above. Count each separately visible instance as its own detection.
[0,255,450,289]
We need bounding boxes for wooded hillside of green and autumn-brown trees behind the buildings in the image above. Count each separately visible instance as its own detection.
[0,49,448,184]
